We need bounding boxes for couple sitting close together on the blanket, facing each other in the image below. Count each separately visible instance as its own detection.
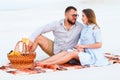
[29,6,109,66]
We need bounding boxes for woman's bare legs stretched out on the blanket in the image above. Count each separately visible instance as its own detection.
[36,51,79,67]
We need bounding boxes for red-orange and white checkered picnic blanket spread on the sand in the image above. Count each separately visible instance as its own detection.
[0,53,120,75]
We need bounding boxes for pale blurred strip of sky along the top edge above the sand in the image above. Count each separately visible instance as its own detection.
[0,0,120,10]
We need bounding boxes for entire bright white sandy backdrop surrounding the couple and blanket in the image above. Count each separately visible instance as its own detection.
[0,0,120,80]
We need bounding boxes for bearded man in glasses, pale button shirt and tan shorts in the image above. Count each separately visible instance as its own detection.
[29,6,83,56]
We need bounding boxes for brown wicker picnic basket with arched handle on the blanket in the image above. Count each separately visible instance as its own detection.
[7,41,36,69]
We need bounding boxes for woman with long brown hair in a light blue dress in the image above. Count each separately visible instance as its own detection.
[37,9,109,66]
